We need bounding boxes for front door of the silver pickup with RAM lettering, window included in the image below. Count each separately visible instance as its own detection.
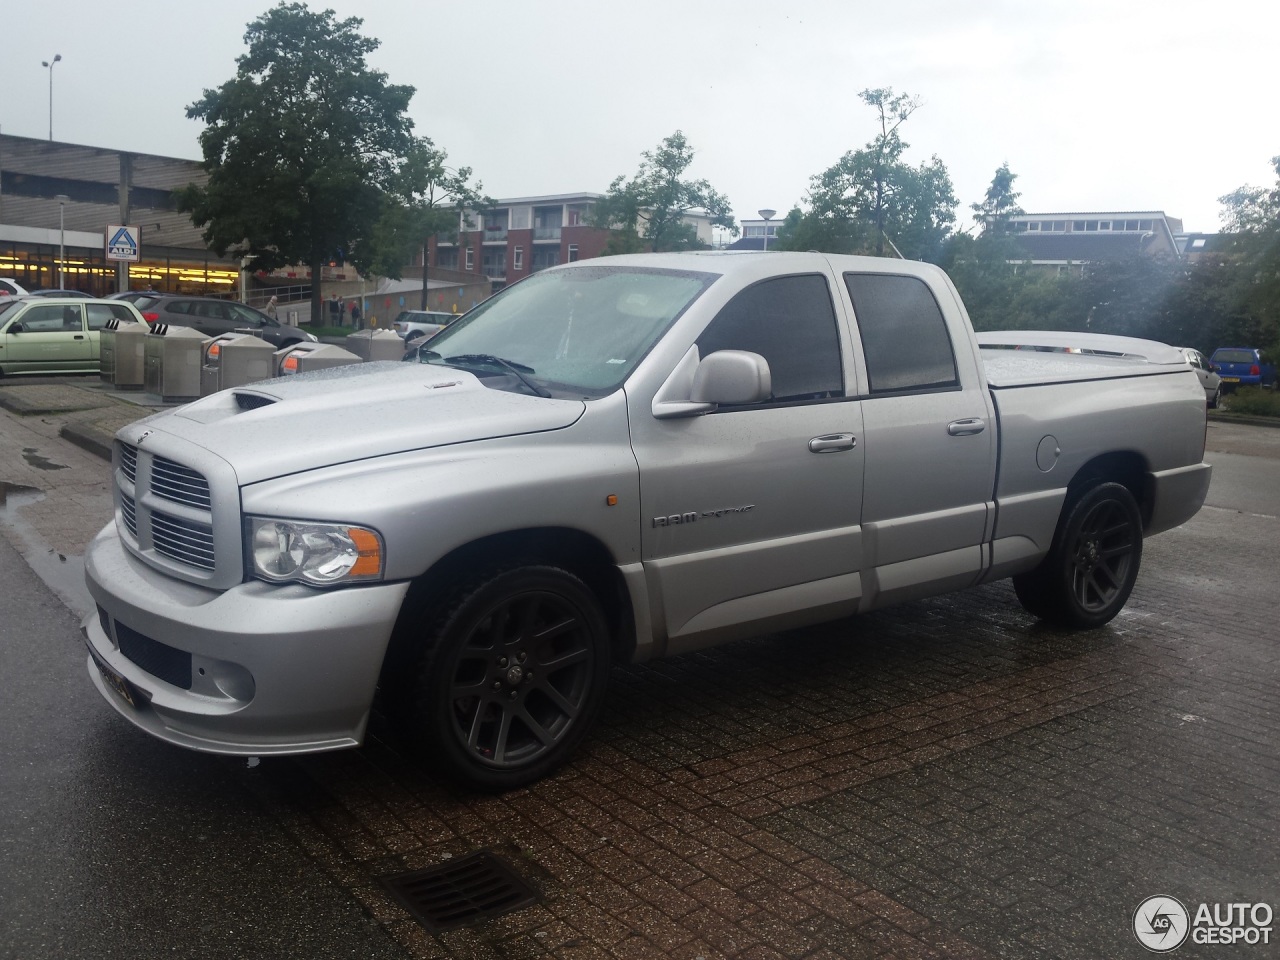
[631,273,863,652]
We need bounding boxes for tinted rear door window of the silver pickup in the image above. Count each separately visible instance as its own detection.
[845,274,960,393]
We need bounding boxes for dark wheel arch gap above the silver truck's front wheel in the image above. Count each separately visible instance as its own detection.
[383,527,636,678]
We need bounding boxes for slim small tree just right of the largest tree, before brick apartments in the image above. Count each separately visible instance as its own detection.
[371,137,494,310]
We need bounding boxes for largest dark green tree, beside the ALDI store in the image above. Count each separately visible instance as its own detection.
[179,3,413,321]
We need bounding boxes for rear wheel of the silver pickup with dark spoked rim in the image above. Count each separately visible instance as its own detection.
[1014,483,1142,630]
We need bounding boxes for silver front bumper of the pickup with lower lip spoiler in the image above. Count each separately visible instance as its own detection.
[83,524,408,755]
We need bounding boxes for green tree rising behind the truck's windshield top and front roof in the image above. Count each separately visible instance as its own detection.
[591,131,737,253]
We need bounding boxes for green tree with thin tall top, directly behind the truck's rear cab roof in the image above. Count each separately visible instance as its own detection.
[778,87,957,262]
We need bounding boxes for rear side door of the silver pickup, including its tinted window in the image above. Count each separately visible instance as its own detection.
[845,273,996,609]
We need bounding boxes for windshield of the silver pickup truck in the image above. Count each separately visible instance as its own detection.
[419,264,716,398]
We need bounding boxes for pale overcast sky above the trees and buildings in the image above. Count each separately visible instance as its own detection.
[0,0,1280,230]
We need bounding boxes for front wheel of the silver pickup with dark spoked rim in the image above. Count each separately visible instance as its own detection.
[408,566,609,790]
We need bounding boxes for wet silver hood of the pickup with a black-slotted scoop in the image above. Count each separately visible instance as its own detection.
[120,362,586,484]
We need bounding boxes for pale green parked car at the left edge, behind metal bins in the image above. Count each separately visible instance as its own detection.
[0,297,146,375]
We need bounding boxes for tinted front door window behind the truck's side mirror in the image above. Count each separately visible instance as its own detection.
[698,275,845,401]
